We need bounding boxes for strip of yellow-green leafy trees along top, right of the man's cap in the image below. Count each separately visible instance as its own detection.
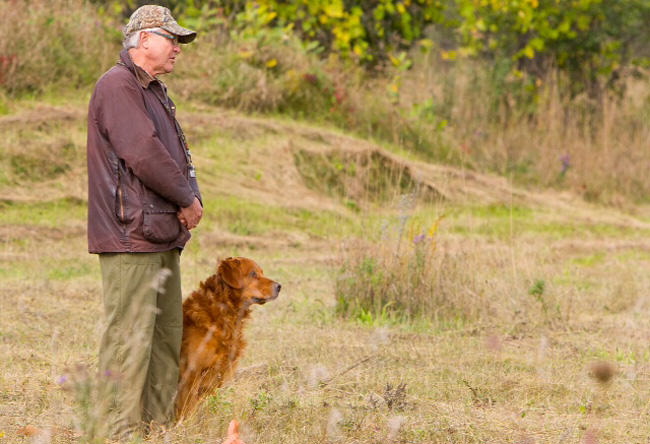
[170,0,650,97]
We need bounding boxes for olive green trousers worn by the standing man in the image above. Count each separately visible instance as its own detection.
[99,249,183,437]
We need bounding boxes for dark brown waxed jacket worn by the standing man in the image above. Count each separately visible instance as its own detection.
[87,50,201,253]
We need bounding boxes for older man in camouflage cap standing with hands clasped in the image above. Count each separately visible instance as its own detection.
[88,5,203,437]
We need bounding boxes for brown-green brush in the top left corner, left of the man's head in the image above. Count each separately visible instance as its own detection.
[0,0,121,94]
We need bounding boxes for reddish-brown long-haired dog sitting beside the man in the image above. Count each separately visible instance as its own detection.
[176,257,281,419]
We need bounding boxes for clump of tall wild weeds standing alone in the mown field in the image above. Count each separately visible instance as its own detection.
[335,212,487,322]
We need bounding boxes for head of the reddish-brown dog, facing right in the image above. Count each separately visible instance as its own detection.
[218,257,282,304]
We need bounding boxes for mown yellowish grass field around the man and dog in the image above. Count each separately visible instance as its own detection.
[0,97,650,444]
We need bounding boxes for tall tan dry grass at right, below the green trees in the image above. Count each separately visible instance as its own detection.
[390,56,650,206]
